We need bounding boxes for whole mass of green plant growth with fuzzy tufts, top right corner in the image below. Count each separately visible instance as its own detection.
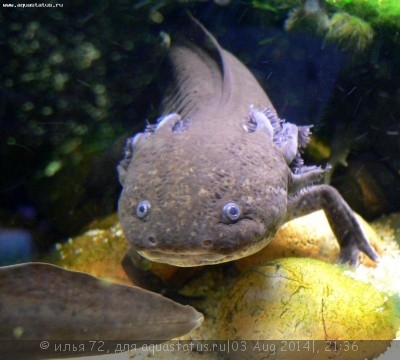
[251,0,400,53]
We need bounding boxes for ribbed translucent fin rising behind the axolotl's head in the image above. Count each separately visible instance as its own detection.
[163,14,231,118]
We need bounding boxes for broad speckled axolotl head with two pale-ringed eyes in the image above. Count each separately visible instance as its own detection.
[118,114,289,266]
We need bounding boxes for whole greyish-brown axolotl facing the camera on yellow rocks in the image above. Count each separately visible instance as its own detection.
[118,20,378,267]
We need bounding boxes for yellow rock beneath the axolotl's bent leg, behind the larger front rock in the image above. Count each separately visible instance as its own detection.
[236,210,382,270]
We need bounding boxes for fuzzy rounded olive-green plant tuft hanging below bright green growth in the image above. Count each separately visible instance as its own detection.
[325,12,374,53]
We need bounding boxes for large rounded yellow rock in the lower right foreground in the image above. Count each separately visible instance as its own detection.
[219,258,400,359]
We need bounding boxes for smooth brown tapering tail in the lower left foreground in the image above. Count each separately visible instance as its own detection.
[0,263,203,360]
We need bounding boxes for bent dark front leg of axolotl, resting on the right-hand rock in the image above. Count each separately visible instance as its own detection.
[286,181,379,265]
